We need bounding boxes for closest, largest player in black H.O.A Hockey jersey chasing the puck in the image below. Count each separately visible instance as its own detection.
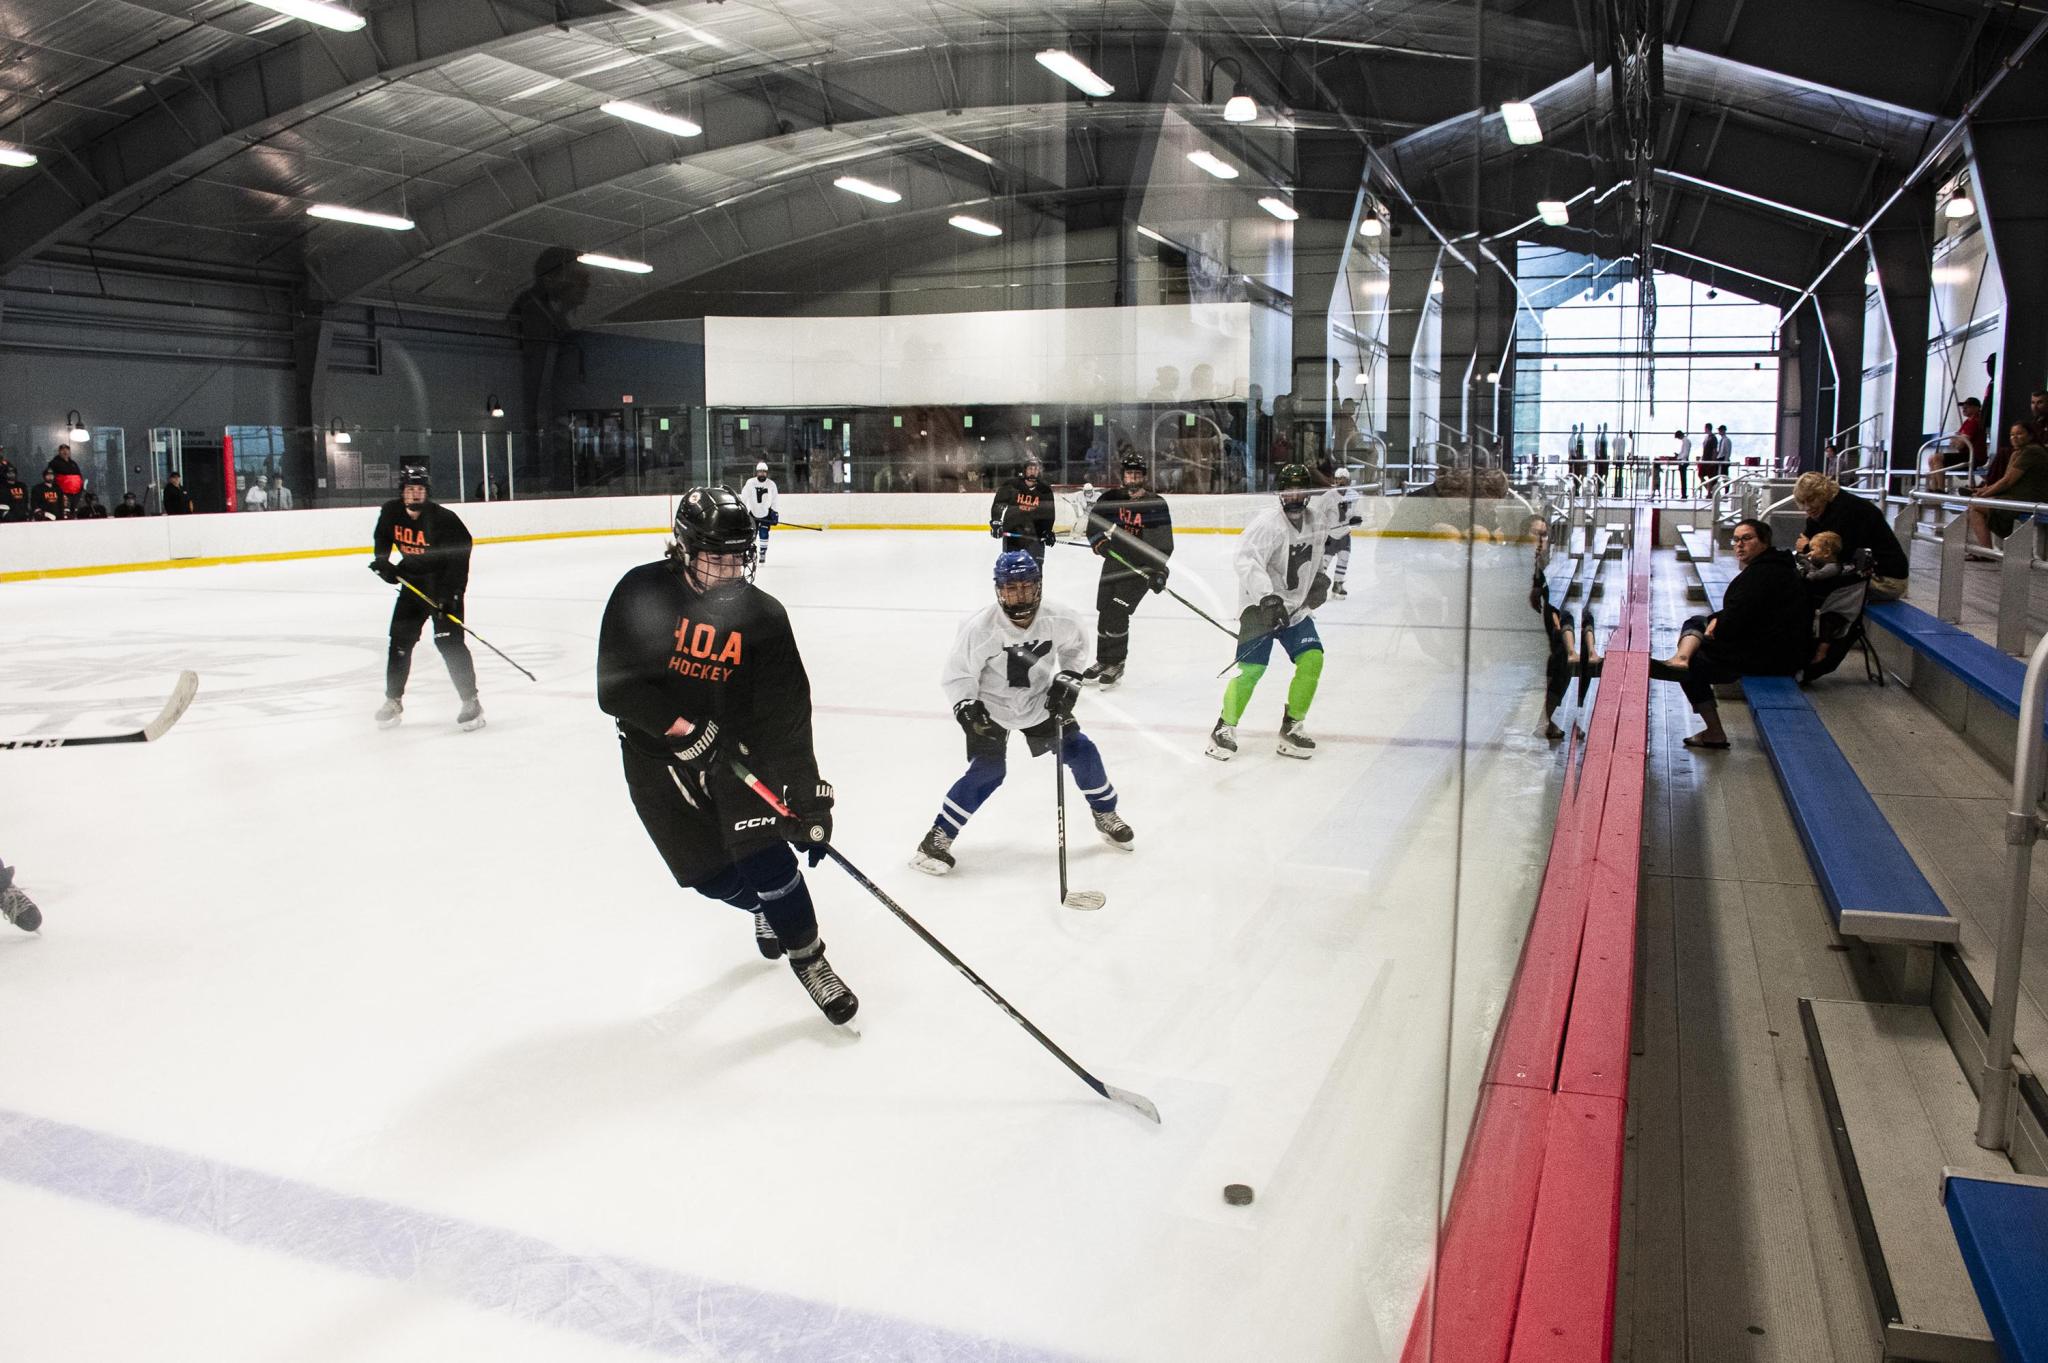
[598,487,860,1025]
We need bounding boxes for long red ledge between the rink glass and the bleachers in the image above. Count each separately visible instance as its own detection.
[1401,512,1651,1363]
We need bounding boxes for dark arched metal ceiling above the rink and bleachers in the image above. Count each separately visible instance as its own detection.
[0,0,2038,313]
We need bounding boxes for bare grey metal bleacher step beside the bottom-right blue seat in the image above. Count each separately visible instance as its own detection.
[1800,999,2011,1363]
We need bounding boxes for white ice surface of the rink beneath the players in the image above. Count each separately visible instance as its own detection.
[0,530,1559,1363]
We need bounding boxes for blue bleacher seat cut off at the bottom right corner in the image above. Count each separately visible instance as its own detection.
[1942,1169,2048,1363]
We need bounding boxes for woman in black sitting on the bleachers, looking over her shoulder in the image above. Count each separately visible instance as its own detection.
[1651,520,1812,749]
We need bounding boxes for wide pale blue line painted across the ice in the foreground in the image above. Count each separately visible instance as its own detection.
[0,1109,1061,1363]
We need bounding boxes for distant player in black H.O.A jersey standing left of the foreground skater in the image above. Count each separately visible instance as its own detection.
[371,465,483,729]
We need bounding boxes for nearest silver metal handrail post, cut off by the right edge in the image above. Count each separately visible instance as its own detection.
[1976,634,2048,1150]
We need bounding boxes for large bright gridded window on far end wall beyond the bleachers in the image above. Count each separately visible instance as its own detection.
[1516,246,1778,465]
